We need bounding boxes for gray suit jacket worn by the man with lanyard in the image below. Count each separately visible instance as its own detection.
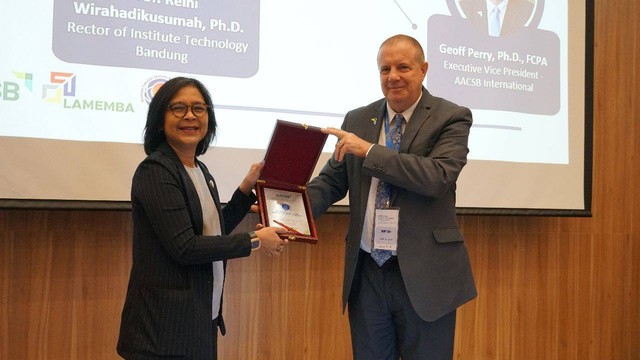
[308,88,477,321]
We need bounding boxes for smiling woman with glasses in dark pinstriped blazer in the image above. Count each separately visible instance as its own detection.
[117,77,287,359]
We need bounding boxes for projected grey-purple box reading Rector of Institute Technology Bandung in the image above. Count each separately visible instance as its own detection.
[53,0,260,78]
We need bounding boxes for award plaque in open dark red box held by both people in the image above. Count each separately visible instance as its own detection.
[256,120,327,244]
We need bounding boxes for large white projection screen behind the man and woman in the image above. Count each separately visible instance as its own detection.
[0,0,593,216]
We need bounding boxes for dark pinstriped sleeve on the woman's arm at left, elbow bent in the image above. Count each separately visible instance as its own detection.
[131,159,251,264]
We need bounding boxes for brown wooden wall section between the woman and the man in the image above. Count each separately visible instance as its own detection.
[220,215,351,359]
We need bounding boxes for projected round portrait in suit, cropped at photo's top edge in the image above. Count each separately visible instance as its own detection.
[460,0,533,36]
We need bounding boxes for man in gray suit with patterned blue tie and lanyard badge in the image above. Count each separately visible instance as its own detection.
[308,35,477,360]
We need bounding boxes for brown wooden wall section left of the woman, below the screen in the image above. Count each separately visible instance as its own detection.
[0,210,131,359]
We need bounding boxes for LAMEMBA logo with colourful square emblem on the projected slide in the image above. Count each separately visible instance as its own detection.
[42,71,134,112]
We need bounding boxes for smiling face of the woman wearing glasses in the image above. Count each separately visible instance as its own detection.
[164,86,209,156]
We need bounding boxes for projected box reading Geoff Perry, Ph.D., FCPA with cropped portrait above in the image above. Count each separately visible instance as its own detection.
[427,0,560,115]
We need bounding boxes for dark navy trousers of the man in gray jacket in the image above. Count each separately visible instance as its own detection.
[349,251,456,360]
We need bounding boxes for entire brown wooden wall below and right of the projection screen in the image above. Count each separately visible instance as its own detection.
[0,0,640,360]
